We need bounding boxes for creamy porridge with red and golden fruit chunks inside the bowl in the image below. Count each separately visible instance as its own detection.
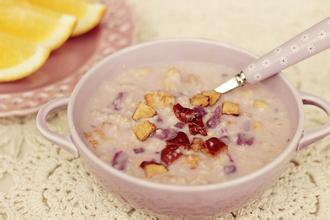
[81,62,292,185]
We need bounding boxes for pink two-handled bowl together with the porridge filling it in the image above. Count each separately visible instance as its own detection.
[37,39,330,216]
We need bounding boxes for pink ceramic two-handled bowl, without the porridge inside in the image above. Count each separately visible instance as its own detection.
[37,39,330,216]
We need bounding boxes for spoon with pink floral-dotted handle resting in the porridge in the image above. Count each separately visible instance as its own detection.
[215,17,330,93]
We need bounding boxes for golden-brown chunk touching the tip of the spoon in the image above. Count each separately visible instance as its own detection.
[190,90,221,107]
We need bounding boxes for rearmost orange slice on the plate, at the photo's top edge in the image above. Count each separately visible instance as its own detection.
[28,0,106,36]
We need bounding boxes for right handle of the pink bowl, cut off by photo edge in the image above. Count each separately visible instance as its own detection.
[297,92,330,150]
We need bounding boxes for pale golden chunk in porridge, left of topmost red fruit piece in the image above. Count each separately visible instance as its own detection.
[144,92,175,108]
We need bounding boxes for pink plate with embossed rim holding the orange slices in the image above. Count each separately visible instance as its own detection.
[0,0,134,117]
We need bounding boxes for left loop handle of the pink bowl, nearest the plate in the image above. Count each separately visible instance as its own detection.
[36,97,79,157]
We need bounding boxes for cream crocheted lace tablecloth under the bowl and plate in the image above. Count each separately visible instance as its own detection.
[0,0,330,220]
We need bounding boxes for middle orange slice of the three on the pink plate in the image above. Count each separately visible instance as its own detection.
[0,0,76,50]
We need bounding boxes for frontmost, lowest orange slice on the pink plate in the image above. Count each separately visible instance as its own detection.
[0,31,50,82]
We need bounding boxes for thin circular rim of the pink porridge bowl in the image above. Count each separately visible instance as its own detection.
[67,38,304,193]
